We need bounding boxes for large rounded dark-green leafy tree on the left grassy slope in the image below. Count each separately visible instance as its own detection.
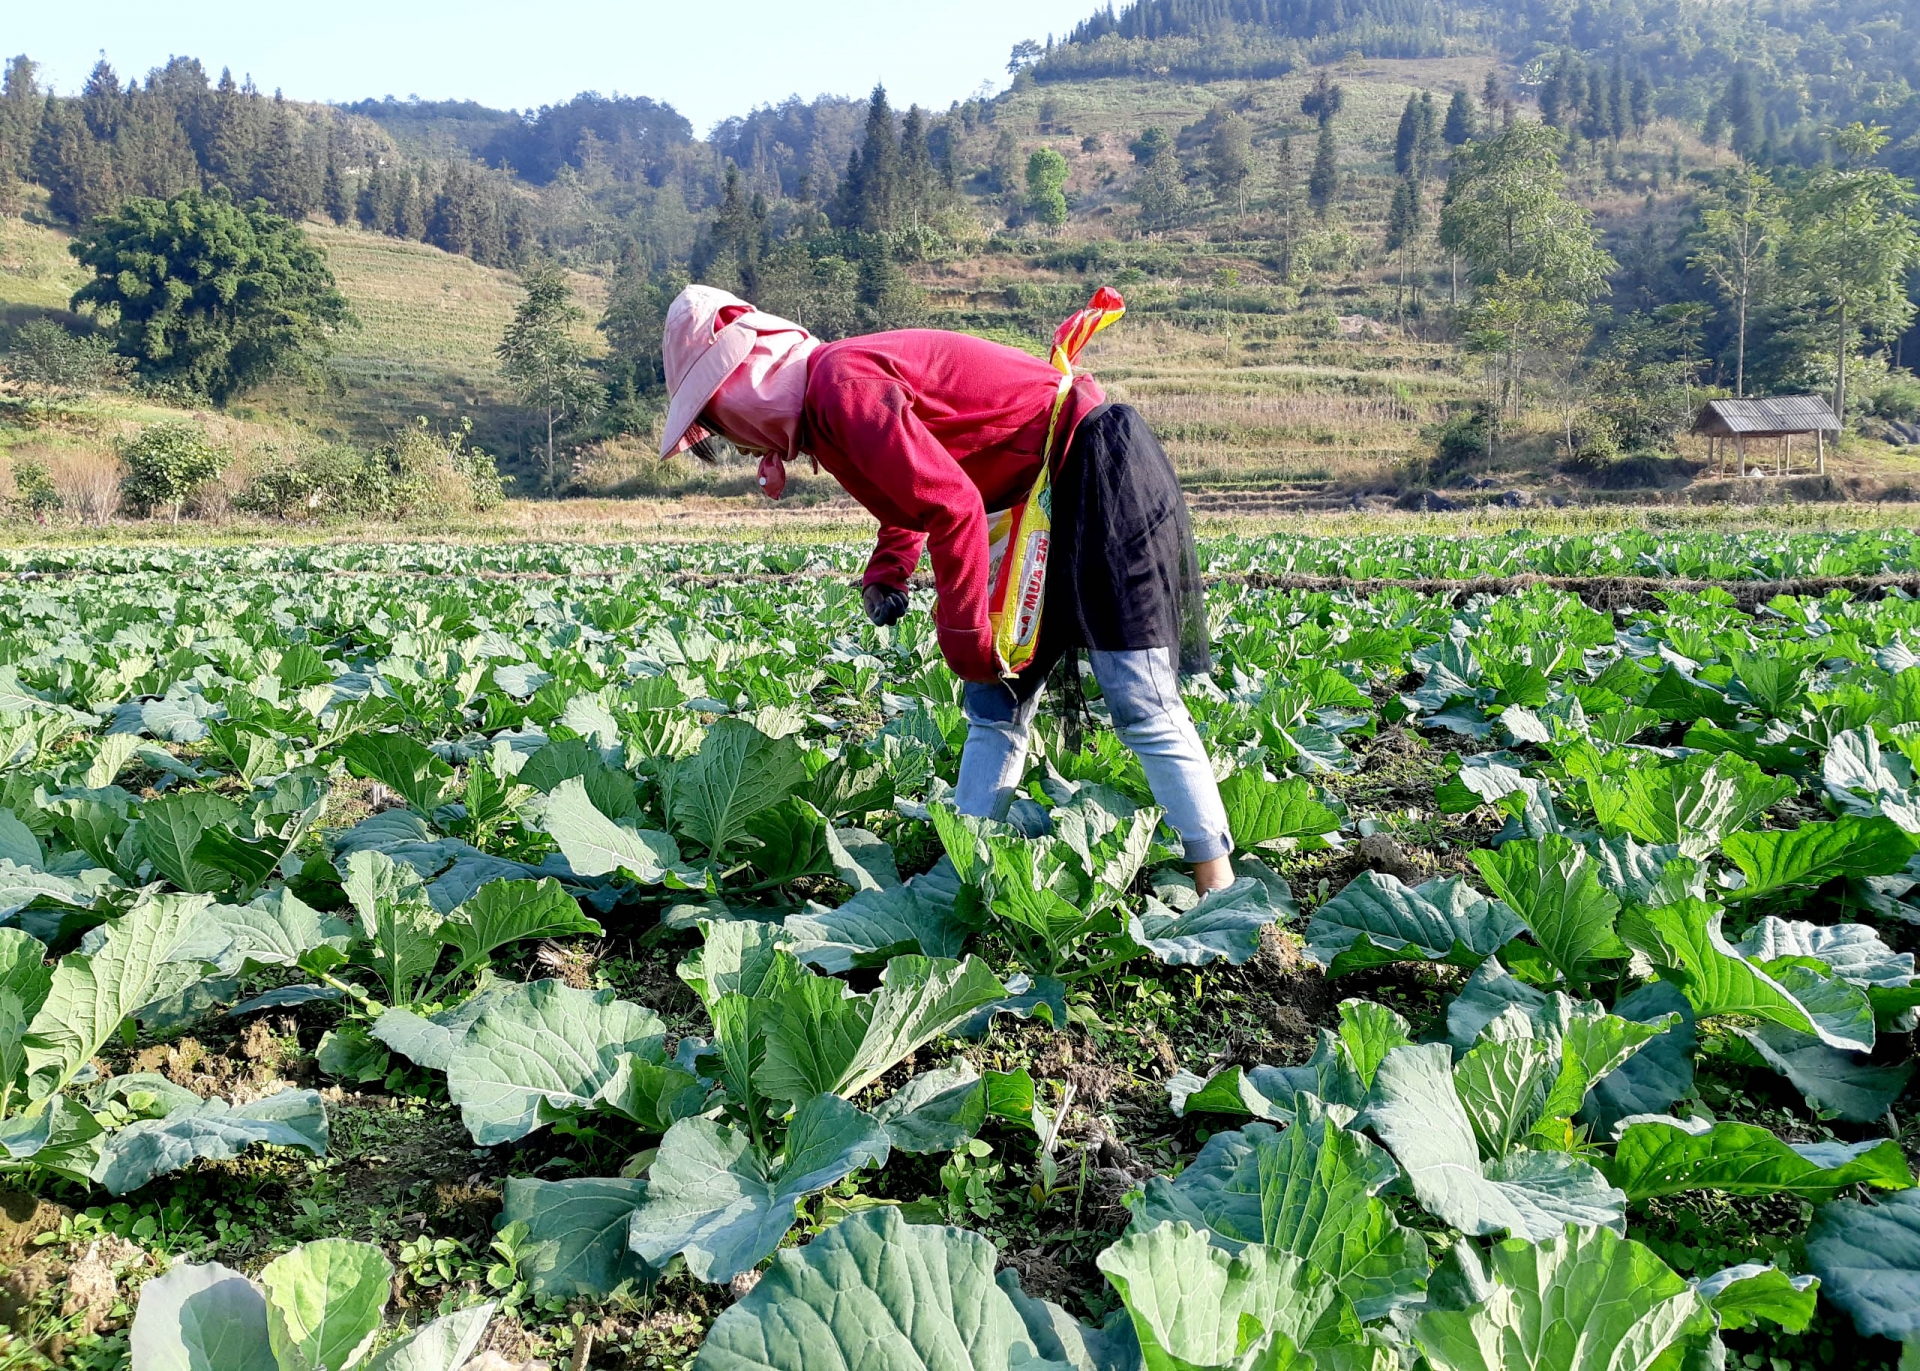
[71,190,353,403]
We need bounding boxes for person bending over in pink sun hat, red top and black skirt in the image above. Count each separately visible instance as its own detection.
[660,286,1233,893]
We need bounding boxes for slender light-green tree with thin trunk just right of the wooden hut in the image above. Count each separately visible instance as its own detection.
[1789,123,1920,424]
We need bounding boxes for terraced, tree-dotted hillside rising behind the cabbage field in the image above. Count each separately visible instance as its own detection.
[0,0,1920,507]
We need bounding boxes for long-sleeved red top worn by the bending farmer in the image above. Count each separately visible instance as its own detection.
[799,328,1104,682]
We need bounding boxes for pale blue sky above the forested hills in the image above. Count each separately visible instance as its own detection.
[15,0,1094,134]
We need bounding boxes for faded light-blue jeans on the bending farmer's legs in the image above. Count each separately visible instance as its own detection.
[954,647,1233,862]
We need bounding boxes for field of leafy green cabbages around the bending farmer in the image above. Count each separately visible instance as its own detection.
[11,532,1920,1371]
